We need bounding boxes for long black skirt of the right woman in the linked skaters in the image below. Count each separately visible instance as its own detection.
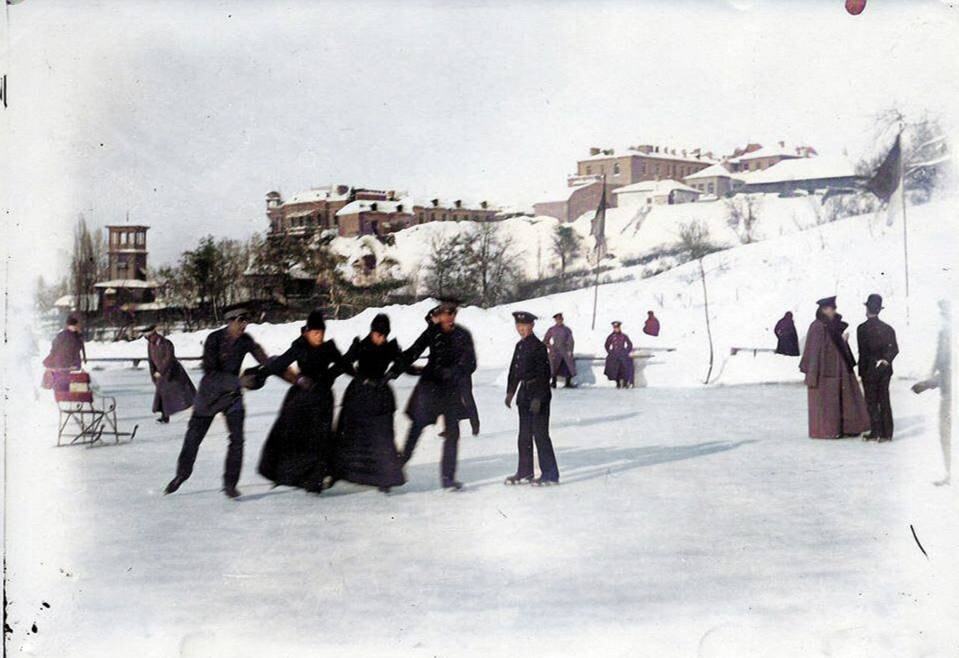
[335,379,406,487]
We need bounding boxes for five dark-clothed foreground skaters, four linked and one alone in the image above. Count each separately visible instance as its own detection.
[159,301,559,498]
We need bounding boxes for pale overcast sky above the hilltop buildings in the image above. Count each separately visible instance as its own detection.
[3,0,959,266]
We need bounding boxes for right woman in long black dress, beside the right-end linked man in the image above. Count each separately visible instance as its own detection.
[336,313,406,491]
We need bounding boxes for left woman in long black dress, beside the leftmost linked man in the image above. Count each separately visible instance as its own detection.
[258,311,347,493]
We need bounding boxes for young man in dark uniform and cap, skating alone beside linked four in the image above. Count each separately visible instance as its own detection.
[506,311,559,485]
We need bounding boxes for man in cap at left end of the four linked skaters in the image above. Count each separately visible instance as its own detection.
[164,308,267,498]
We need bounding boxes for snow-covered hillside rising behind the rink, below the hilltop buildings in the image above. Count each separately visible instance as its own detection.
[77,192,956,386]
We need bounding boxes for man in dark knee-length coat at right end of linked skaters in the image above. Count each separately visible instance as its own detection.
[390,301,476,489]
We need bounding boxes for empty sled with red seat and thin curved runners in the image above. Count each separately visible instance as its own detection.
[49,369,139,446]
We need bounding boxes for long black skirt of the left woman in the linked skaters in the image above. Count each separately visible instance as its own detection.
[258,386,333,491]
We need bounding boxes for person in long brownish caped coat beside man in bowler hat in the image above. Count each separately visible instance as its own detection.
[799,297,869,439]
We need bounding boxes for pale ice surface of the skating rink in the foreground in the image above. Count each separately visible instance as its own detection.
[7,367,959,658]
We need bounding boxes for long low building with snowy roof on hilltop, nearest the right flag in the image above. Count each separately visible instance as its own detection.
[740,156,863,194]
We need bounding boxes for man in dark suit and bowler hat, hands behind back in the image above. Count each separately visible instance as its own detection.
[856,294,899,441]
